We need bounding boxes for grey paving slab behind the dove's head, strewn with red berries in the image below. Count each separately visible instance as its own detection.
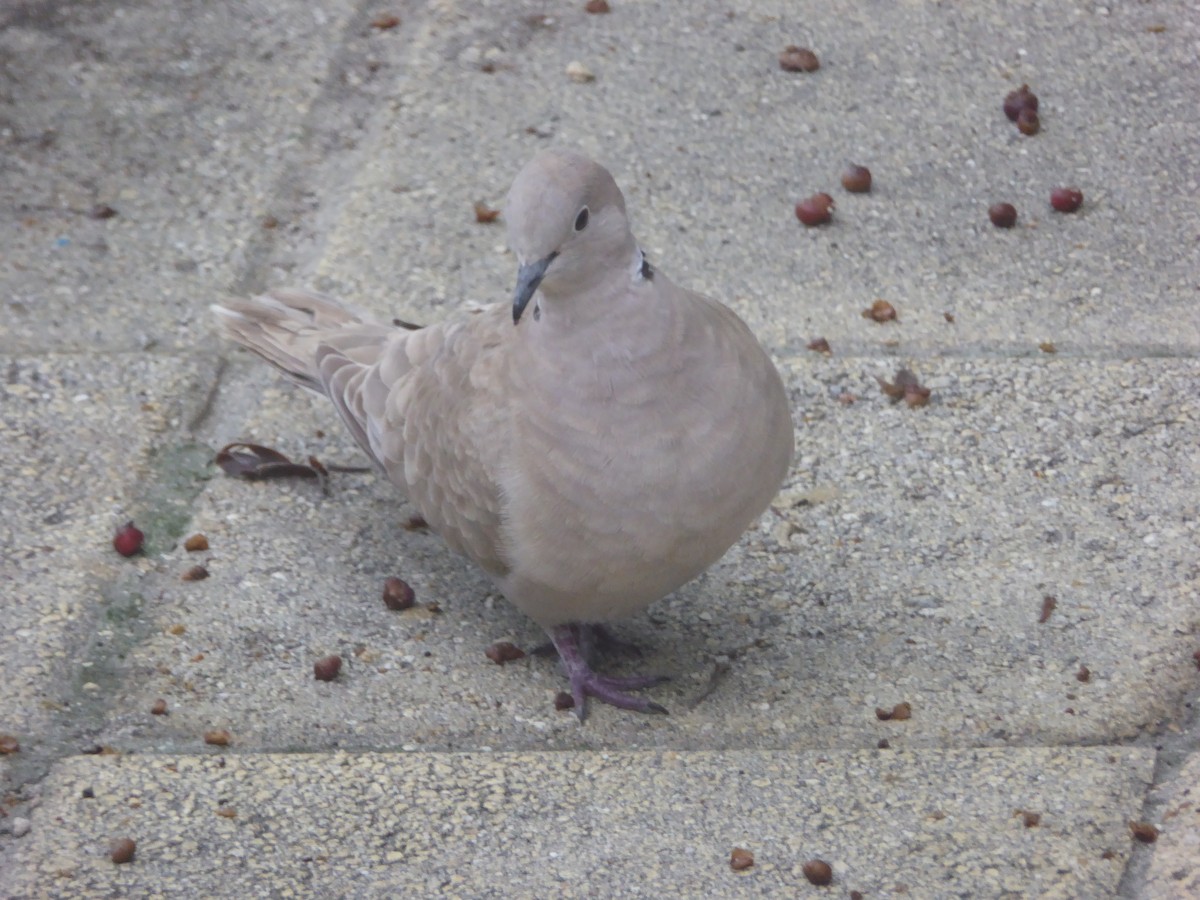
[313,1,1200,356]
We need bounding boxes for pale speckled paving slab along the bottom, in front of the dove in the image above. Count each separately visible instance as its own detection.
[8,748,1153,898]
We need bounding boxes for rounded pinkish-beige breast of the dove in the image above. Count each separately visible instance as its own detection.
[500,282,793,626]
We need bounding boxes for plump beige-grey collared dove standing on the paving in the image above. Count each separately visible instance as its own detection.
[212,149,793,718]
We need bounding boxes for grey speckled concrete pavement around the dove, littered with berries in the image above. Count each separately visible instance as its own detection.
[0,0,1200,898]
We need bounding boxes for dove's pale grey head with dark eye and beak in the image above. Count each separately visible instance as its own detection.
[504,148,637,323]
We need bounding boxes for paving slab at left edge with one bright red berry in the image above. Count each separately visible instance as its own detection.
[0,353,217,755]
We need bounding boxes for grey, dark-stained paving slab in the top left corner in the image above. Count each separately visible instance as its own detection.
[0,0,376,352]
